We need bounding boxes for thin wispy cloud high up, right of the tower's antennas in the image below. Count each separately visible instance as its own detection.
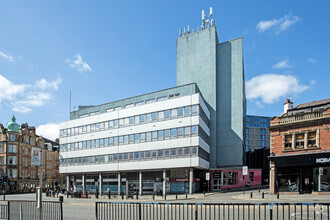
[257,13,300,33]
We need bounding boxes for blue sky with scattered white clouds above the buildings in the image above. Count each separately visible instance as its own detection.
[0,0,330,138]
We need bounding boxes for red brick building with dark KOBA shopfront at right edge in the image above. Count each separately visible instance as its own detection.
[269,99,330,194]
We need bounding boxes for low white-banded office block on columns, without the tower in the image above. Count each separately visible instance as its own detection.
[60,84,210,193]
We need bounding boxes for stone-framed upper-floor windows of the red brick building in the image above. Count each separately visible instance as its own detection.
[284,131,317,150]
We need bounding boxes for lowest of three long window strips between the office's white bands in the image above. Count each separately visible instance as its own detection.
[60,146,209,166]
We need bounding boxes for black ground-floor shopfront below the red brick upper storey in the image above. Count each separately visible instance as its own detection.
[269,152,330,193]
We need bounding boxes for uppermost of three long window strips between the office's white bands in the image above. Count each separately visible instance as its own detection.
[60,105,209,138]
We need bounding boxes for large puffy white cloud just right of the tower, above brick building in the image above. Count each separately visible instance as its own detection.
[246,73,309,104]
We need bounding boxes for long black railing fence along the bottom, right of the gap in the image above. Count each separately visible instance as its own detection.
[95,202,330,220]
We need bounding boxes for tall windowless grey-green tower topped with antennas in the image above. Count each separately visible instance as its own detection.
[177,8,246,168]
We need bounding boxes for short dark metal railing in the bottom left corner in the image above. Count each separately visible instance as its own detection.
[7,201,63,220]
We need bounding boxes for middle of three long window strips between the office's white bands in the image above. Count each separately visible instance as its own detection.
[60,125,210,152]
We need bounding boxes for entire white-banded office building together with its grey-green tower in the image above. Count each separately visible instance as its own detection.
[60,10,246,193]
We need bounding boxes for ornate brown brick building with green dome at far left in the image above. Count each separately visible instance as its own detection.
[0,116,63,193]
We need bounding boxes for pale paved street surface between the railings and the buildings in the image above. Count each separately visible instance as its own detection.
[0,189,330,220]
